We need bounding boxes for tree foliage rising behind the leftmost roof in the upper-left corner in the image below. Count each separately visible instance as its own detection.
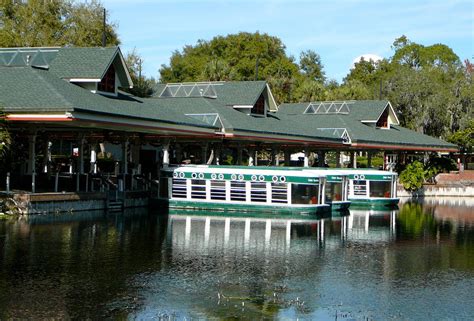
[0,0,120,47]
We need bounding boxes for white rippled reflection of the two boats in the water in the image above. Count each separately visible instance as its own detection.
[168,210,398,252]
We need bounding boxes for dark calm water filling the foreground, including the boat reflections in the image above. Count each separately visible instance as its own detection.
[0,201,474,320]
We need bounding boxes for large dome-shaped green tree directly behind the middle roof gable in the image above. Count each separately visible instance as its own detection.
[160,32,308,102]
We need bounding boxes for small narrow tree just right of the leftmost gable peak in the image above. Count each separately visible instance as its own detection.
[124,49,156,97]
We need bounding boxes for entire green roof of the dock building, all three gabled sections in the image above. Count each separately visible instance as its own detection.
[0,47,456,149]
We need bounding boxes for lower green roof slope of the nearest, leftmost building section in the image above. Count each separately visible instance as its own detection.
[0,66,211,128]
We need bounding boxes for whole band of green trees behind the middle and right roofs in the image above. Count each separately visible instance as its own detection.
[160,32,474,138]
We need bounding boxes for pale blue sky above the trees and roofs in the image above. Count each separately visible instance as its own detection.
[101,0,474,82]
